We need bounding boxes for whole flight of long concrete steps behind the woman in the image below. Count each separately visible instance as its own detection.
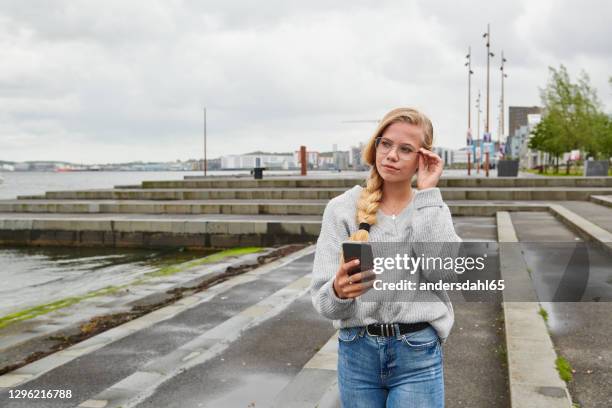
[0,176,612,248]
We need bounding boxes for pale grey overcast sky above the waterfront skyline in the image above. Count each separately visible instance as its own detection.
[0,0,612,163]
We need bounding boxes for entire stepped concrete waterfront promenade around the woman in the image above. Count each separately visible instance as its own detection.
[0,174,612,407]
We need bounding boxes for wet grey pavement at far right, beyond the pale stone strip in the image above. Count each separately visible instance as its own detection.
[512,212,612,407]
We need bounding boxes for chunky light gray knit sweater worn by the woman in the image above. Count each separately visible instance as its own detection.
[310,185,461,343]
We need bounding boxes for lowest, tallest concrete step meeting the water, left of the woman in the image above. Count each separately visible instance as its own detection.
[0,213,321,249]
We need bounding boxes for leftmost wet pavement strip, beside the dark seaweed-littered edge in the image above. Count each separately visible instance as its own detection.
[0,255,316,407]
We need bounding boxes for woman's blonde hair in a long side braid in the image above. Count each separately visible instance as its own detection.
[349,108,433,241]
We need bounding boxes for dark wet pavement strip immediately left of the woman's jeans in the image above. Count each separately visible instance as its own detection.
[137,294,335,408]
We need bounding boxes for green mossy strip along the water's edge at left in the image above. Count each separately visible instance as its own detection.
[0,247,261,329]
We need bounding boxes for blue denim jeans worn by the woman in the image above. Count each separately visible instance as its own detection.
[338,326,444,408]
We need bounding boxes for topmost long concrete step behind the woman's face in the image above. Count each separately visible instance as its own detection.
[134,174,612,188]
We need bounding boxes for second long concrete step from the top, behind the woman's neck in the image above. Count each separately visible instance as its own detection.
[18,187,612,201]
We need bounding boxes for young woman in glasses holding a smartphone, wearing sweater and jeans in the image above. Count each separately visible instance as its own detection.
[310,108,461,408]
